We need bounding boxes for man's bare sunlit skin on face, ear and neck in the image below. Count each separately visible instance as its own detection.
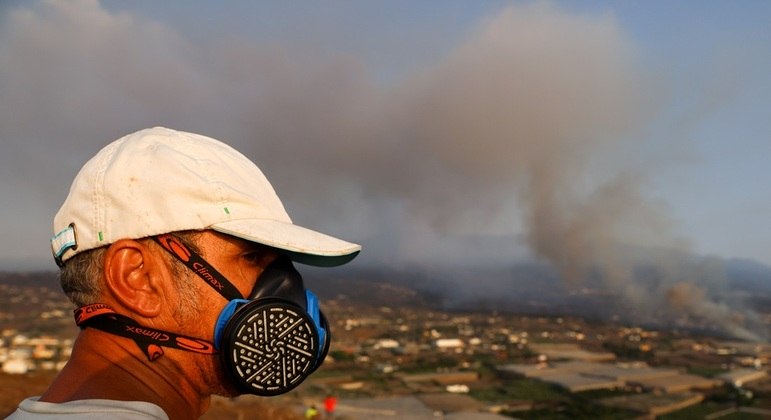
[40,231,277,419]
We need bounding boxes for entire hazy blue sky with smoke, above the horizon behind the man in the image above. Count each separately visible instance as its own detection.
[0,0,771,269]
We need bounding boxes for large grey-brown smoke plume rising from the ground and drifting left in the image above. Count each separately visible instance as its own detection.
[0,0,756,338]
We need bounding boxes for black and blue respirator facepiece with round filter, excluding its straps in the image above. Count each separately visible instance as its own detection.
[215,257,329,396]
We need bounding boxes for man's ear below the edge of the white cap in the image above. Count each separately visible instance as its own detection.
[104,239,164,317]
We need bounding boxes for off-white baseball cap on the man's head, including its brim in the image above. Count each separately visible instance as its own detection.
[51,127,361,266]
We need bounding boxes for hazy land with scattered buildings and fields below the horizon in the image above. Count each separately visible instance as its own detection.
[0,270,771,419]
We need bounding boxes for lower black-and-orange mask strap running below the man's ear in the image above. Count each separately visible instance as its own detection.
[75,303,217,361]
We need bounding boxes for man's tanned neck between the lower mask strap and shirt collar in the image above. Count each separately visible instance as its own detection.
[40,328,209,419]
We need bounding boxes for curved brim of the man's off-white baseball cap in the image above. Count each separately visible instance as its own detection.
[211,219,361,267]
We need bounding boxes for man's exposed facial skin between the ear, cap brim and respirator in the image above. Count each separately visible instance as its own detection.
[161,231,278,396]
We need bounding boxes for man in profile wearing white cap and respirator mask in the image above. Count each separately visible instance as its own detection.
[10,127,361,419]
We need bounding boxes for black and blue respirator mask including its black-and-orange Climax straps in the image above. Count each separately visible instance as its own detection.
[75,235,330,396]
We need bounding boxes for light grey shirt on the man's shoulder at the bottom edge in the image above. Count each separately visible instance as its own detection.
[7,397,169,420]
